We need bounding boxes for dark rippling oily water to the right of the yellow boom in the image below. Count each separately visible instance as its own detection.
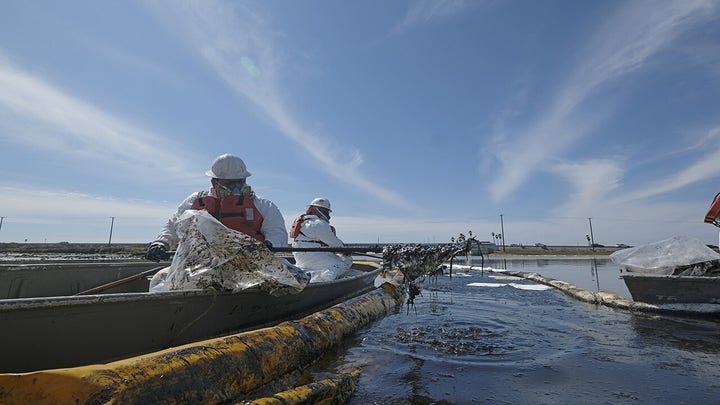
[337,259,720,404]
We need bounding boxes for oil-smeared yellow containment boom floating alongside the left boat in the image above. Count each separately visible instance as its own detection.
[0,283,402,404]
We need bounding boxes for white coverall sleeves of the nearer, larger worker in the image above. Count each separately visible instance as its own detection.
[152,191,288,250]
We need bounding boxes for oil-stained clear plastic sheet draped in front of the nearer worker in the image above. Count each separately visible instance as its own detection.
[150,210,310,295]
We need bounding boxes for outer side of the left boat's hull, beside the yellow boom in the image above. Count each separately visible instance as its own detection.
[0,262,381,372]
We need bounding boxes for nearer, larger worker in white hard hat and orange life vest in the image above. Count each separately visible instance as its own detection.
[145,154,288,261]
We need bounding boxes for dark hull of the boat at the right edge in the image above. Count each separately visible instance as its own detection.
[621,273,720,304]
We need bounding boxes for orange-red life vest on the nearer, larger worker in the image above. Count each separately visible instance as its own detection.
[191,195,265,241]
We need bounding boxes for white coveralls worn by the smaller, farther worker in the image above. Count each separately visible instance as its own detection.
[292,214,352,282]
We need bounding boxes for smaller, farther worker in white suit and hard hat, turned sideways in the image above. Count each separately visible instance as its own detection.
[290,198,352,282]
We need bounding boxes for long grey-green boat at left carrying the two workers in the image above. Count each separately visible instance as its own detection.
[0,261,382,373]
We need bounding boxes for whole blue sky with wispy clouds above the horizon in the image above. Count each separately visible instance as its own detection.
[0,0,720,245]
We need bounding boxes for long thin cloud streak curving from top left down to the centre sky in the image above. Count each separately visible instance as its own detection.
[149,1,417,210]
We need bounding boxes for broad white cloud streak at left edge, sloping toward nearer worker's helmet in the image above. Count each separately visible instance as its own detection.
[0,53,200,183]
